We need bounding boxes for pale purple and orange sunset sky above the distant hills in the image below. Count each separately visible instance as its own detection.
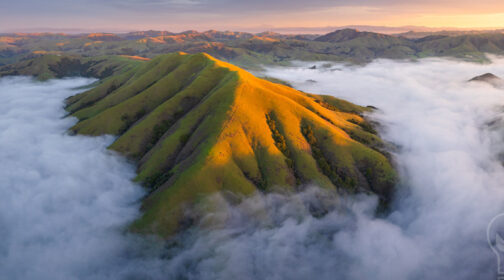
[0,0,504,32]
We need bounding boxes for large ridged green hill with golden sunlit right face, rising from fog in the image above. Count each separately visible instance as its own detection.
[68,53,395,236]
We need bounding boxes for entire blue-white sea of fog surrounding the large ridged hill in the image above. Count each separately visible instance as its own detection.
[0,58,504,280]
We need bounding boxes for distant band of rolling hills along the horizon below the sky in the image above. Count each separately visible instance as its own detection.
[0,29,504,69]
